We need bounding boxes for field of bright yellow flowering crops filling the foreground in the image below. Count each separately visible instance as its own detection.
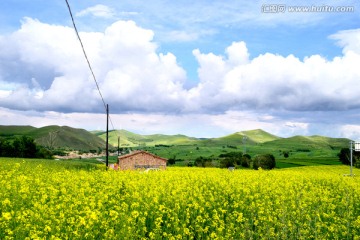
[0,159,360,239]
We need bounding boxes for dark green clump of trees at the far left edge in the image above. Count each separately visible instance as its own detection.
[0,136,53,158]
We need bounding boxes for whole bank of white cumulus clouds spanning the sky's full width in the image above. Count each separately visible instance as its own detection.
[0,18,360,117]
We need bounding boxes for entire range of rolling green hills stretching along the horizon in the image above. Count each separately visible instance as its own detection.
[0,126,350,166]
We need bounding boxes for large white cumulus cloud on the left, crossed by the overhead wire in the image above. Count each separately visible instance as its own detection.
[0,18,186,112]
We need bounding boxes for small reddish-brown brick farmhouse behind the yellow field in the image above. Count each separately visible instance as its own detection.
[118,151,167,170]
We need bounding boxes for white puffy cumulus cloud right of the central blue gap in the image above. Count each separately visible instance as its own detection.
[191,34,360,111]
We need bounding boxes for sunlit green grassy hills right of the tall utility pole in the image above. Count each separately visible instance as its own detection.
[100,129,349,166]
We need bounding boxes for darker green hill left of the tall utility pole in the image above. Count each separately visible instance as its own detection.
[0,126,105,150]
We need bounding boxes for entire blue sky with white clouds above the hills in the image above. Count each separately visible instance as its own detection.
[0,0,360,140]
